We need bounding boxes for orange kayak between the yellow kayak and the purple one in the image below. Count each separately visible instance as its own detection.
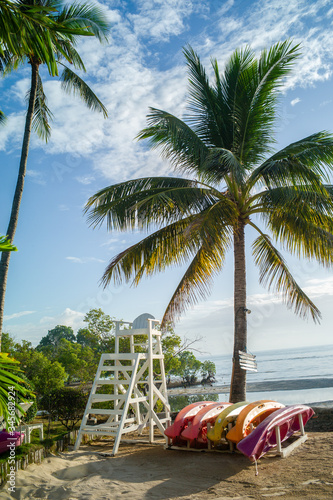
[226,399,284,443]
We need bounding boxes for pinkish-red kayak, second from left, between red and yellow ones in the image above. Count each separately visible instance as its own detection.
[181,403,232,443]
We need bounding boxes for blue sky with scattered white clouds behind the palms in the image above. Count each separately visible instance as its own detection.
[0,0,333,354]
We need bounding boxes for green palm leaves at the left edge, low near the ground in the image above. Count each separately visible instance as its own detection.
[0,353,35,424]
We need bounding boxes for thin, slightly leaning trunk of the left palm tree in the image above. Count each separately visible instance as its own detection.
[0,61,39,351]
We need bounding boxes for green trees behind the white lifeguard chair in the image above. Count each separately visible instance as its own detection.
[2,309,216,398]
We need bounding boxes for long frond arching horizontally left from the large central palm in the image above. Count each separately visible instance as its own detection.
[85,177,234,231]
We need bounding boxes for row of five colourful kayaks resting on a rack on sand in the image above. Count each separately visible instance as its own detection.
[165,400,314,461]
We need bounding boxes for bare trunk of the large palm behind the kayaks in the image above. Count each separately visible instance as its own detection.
[230,220,247,403]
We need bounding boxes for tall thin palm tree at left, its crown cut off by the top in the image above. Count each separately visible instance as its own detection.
[0,0,108,340]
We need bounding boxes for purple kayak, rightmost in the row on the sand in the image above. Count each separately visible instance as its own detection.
[237,404,314,461]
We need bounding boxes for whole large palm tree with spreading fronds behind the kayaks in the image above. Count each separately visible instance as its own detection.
[86,41,333,402]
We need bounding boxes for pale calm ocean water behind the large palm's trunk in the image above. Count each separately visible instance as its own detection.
[200,345,333,404]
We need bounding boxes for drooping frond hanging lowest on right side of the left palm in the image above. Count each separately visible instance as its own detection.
[60,64,108,118]
